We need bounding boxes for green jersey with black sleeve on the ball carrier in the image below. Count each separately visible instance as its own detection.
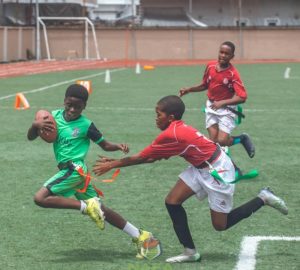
[52,109,104,163]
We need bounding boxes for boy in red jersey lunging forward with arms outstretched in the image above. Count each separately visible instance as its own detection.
[93,96,288,263]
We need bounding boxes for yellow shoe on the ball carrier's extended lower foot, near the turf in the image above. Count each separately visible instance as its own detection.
[132,230,162,260]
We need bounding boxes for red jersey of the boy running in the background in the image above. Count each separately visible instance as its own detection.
[202,61,247,101]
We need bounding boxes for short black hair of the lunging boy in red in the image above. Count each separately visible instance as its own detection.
[157,95,185,120]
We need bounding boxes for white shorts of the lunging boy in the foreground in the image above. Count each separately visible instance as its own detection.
[179,151,235,213]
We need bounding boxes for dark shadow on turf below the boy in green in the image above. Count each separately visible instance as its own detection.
[52,249,135,263]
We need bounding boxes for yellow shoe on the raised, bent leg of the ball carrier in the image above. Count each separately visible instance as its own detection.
[83,198,105,230]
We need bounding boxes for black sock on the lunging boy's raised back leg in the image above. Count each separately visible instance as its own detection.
[226,197,264,229]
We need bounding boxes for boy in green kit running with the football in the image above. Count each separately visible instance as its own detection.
[27,84,160,258]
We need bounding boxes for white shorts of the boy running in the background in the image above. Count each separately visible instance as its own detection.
[205,100,236,134]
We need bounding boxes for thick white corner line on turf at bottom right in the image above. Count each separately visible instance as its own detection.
[234,236,300,270]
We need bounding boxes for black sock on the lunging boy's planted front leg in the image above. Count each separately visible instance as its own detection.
[166,203,195,249]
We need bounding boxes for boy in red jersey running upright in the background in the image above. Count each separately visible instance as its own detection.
[179,41,255,158]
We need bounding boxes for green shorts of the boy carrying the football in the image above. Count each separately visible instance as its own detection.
[44,162,98,200]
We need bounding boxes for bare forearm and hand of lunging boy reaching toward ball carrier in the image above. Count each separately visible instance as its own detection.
[93,154,155,176]
